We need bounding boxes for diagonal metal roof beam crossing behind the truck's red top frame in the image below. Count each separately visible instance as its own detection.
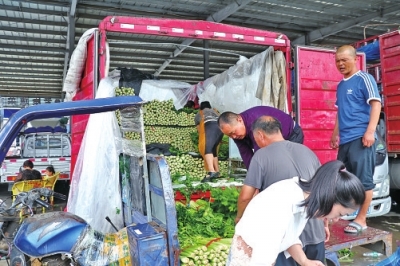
[154,0,251,77]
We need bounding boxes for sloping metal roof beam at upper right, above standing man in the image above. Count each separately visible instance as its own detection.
[292,5,400,45]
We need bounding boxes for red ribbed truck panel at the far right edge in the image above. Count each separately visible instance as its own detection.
[379,31,400,153]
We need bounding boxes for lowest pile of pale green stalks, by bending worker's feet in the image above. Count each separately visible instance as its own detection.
[165,154,228,181]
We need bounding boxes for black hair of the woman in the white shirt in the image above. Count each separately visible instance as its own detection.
[299,160,365,218]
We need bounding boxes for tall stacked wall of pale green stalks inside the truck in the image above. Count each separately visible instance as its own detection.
[115,87,228,180]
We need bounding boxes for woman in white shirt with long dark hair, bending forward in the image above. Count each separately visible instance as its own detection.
[227,160,365,266]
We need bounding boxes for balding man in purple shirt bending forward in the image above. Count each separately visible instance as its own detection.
[218,106,304,169]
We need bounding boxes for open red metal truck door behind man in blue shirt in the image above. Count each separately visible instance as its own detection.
[296,46,365,163]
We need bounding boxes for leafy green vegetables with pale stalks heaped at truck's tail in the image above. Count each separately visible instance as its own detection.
[176,184,239,265]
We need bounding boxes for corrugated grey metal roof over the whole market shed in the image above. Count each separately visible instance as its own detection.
[0,0,400,97]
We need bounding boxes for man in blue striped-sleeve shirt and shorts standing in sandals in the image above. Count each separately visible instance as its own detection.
[330,45,381,233]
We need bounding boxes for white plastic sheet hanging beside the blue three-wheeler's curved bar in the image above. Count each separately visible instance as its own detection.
[67,78,124,233]
